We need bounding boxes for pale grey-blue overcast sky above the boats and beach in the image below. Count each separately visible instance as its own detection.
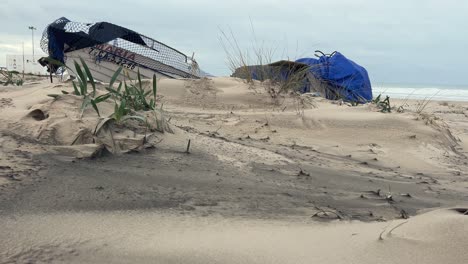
[0,0,468,85]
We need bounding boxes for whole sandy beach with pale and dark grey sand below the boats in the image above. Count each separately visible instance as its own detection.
[0,77,468,264]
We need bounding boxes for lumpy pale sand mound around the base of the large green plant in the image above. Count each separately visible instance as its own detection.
[0,83,169,157]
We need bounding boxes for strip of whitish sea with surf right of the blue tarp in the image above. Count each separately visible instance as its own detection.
[372,84,468,101]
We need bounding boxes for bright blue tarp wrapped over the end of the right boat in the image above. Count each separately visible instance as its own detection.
[296,52,372,103]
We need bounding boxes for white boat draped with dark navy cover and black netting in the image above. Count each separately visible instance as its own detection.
[41,17,200,78]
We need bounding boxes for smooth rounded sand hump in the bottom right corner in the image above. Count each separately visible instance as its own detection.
[356,208,468,263]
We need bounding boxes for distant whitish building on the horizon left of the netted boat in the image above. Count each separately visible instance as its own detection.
[6,55,48,75]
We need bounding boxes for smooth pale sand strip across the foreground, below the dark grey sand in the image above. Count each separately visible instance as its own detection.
[0,209,468,264]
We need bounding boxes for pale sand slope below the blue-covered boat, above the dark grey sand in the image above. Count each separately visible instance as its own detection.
[158,77,466,177]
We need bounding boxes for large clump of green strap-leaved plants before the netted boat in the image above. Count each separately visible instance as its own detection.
[43,58,171,153]
